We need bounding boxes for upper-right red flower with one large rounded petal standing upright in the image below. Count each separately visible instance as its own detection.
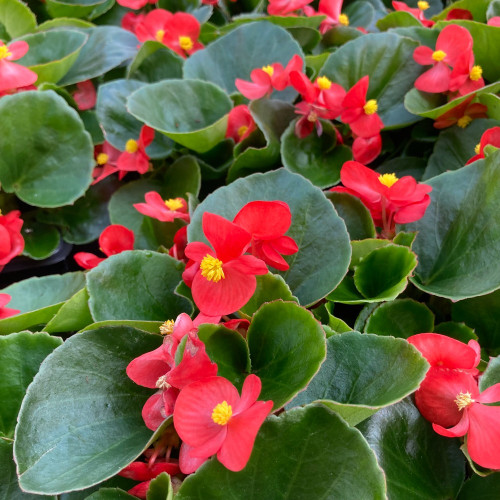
[413,24,472,92]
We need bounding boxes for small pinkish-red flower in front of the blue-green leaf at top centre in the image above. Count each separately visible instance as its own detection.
[235,54,304,99]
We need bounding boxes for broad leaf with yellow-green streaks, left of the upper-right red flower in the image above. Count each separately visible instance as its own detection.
[321,33,422,128]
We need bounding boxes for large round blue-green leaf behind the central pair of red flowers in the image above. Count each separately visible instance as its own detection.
[188,169,350,305]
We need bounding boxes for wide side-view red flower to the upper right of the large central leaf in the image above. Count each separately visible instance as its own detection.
[331,161,432,238]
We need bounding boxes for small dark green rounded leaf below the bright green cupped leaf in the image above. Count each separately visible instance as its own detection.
[364,299,434,339]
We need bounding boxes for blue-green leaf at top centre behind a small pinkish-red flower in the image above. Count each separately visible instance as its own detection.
[184,21,304,102]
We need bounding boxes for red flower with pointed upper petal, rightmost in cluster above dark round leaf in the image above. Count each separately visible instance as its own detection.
[340,75,384,137]
